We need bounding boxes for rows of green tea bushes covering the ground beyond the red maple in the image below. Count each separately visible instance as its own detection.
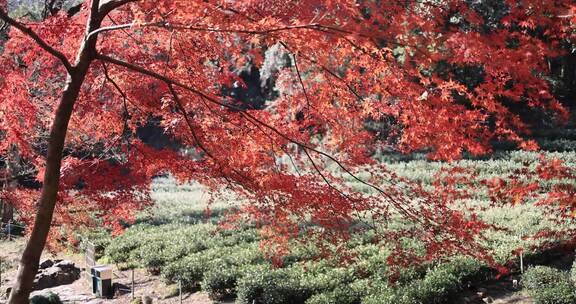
[85,151,576,304]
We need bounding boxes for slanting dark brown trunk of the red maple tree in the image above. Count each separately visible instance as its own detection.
[8,0,103,304]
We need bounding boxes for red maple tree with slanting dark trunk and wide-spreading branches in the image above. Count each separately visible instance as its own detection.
[0,0,575,303]
